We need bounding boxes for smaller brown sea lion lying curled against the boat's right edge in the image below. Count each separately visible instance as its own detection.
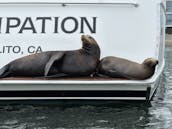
[96,56,158,80]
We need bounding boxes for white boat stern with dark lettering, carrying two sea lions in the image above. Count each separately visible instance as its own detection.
[0,0,166,101]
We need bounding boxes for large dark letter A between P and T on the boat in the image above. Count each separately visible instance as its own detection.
[19,17,36,33]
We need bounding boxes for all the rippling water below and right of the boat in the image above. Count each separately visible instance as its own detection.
[0,47,172,129]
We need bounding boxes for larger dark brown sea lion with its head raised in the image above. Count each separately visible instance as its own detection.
[0,35,100,78]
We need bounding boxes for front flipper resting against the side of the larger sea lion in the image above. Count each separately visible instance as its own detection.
[44,52,64,76]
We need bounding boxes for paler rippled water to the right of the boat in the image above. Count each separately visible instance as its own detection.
[148,47,172,129]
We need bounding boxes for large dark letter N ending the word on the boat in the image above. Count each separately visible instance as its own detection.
[80,17,97,33]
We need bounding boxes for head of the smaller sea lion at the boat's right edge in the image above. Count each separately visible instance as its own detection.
[142,58,158,69]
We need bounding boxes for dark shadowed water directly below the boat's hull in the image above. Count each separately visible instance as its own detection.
[0,103,151,129]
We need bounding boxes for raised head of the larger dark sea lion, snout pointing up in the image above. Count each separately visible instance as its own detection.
[81,35,100,57]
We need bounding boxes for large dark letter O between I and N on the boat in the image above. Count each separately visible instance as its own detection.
[61,17,78,33]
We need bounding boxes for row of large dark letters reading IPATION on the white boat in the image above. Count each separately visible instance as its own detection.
[3,16,97,34]
